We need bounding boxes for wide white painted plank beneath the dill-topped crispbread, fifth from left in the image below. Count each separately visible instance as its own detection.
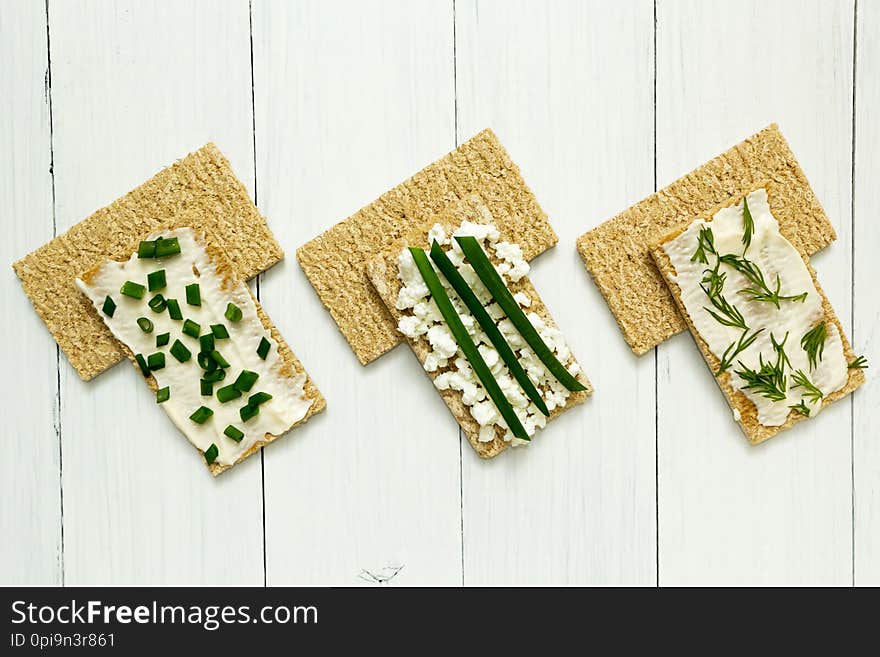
[657,0,853,584]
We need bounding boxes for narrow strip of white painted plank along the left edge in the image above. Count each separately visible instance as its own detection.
[0,0,62,585]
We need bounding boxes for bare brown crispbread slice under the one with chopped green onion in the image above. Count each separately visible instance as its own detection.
[13,144,284,381]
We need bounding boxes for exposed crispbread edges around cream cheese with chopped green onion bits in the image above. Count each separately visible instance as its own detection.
[77,225,327,477]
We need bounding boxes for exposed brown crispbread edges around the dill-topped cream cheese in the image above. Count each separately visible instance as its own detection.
[650,183,865,445]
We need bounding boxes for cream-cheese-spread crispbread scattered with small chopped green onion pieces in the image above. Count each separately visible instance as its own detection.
[77,227,325,476]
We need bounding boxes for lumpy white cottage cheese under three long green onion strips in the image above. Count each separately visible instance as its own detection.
[396,221,580,445]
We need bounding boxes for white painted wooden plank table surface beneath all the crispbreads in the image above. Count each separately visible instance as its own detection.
[0,0,880,585]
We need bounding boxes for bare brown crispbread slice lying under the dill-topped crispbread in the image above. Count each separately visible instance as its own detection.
[577,123,836,355]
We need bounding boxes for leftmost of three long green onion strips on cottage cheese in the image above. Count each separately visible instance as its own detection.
[409,247,530,440]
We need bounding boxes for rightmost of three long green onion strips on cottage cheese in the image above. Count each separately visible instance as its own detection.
[455,236,586,392]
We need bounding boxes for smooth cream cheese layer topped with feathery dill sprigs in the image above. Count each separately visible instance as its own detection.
[663,189,848,426]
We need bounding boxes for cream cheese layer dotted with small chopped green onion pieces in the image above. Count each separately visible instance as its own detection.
[76,228,312,465]
